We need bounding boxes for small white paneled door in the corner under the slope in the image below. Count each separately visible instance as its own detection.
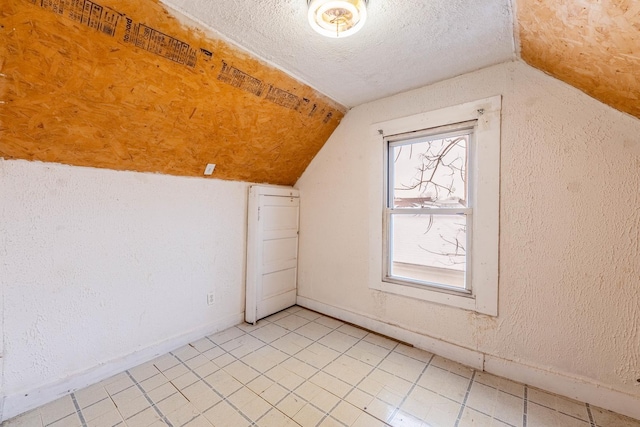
[245,185,300,323]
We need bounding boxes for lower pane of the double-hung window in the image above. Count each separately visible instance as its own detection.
[390,215,467,289]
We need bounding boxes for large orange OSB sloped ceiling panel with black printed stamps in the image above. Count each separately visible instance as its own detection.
[0,0,346,185]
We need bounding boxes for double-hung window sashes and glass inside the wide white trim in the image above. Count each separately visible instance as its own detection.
[385,121,476,293]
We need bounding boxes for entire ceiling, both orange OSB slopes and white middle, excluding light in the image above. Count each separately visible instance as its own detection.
[0,0,640,184]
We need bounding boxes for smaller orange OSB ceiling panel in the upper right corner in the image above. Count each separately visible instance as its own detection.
[518,0,640,118]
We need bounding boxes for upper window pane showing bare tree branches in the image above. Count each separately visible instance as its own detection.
[389,128,473,208]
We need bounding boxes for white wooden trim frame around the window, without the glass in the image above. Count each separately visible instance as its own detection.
[369,96,502,316]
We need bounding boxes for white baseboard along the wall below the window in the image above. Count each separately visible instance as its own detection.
[297,296,640,419]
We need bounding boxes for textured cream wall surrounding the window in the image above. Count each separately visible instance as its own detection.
[296,62,640,400]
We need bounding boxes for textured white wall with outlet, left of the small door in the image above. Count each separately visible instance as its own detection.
[0,160,247,418]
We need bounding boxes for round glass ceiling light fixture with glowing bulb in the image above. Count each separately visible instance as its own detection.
[307,0,367,38]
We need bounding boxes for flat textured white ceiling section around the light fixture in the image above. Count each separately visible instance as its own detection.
[162,0,515,107]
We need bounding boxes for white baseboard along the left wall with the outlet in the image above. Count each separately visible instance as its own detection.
[0,313,244,422]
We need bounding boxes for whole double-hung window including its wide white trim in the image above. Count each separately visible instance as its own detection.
[372,97,501,315]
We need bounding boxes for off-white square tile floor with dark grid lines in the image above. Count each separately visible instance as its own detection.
[2,307,640,427]
